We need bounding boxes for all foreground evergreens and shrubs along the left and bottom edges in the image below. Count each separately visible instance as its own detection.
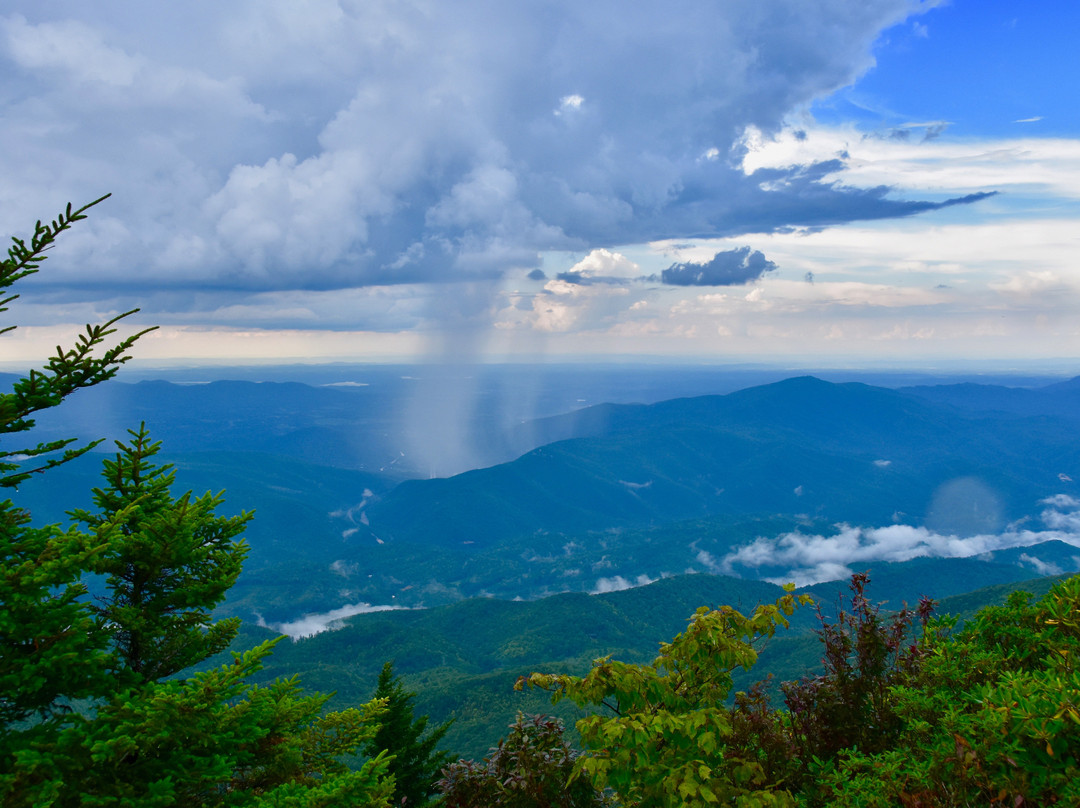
[0,206,1080,808]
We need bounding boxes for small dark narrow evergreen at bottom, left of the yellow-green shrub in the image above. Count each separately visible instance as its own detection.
[365,662,451,808]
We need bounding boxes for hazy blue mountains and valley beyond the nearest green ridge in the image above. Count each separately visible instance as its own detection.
[22,369,1080,625]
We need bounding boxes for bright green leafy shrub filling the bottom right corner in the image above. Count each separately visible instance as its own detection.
[819,577,1080,806]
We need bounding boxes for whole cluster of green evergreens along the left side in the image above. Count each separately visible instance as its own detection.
[0,206,392,808]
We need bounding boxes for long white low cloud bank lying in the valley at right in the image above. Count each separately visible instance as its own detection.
[717,496,1080,587]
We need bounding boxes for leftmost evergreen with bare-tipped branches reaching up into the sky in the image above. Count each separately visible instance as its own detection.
[0,197,149,730]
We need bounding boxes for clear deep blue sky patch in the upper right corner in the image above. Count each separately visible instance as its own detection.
[813,0,1080,137]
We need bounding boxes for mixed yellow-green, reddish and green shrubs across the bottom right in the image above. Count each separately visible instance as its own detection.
[516,576,1080,808]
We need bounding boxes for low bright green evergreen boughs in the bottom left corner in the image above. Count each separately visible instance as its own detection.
[6,643,390,806]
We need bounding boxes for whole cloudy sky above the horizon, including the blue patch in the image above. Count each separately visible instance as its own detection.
[0,0,1080,366]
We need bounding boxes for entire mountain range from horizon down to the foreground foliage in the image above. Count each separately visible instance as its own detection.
[8,372,1080,755]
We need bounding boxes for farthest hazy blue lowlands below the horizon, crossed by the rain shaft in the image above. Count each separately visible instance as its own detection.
[0,364,816,477]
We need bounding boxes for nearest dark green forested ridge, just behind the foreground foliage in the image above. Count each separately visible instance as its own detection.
[230,560,1071,759]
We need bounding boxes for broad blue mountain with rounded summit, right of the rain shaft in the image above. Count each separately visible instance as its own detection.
[368,377,1080,544]
